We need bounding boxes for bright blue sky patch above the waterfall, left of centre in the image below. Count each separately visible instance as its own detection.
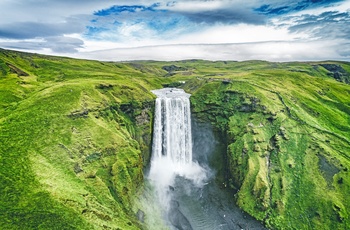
[84,3,192,41]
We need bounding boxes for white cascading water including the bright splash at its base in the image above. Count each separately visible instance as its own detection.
[149,88,206,212]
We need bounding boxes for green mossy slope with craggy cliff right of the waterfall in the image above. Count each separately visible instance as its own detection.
[189,63,350,229]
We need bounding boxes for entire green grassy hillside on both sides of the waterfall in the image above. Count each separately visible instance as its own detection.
[0,50,350,229]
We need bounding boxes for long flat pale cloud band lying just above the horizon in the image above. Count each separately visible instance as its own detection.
[76,41,344,61]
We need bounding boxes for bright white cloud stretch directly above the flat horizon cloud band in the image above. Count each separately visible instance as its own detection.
[76,24,300,51]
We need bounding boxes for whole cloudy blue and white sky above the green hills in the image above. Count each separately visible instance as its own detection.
[0,0,350,61]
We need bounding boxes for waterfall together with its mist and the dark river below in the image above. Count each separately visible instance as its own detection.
[141,88,264,230]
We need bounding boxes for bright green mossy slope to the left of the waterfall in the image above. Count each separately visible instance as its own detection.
[0,51,165,229]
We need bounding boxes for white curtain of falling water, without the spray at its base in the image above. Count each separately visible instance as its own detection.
[152,88,192,167]
